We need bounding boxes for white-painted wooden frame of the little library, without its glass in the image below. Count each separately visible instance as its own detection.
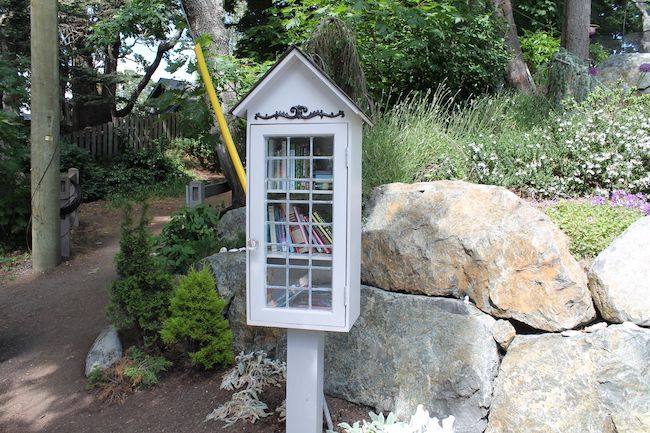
[240,49,370,332]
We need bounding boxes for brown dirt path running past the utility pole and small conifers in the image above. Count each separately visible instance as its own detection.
[0,198,367,433]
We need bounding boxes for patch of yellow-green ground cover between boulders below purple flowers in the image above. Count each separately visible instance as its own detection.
[546,201,643,258]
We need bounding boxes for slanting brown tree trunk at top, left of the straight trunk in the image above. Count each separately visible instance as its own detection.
[494,0,535,93]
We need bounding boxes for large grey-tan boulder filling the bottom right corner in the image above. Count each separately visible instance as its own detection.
[486,325,650,433]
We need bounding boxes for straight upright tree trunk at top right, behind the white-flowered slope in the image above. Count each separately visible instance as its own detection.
[562,0,591,60]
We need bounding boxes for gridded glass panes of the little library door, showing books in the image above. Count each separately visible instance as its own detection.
[265,135,336,310]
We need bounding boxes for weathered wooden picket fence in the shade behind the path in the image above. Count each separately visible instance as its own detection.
[63,113,180,159]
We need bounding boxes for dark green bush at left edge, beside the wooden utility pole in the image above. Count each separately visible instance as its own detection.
[0,111,30,246]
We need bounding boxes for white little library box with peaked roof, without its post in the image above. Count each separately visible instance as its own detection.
[233,48,369,332]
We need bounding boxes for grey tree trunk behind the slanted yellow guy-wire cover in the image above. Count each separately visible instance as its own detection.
[182,0,246,208]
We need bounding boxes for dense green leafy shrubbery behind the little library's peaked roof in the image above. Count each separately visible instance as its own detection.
[235,0,510,99]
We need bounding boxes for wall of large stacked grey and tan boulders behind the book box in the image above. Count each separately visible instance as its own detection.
[207,181,650,433]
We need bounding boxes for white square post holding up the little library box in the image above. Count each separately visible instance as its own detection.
[287,329,325,433]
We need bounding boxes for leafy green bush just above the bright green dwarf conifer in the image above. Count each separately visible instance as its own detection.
[158,205,221,273]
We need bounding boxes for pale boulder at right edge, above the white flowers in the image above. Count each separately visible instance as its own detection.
[598,53,650,93]
